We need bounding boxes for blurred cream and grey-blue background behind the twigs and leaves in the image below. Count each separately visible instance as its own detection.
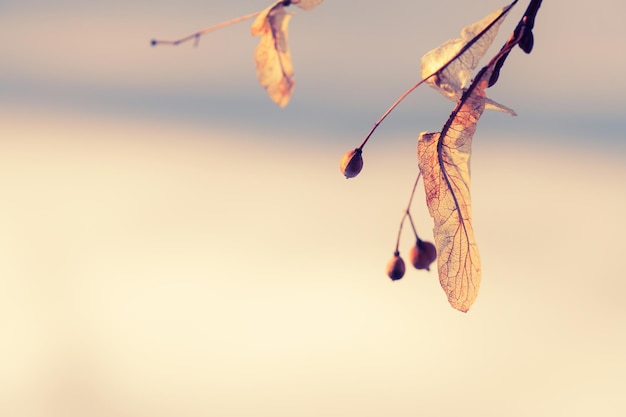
[0,0,626,417]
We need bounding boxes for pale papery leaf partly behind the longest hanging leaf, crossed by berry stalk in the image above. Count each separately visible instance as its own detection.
[421,0,517,115]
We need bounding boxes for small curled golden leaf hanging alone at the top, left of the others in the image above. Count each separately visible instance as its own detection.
[251,1,294,107]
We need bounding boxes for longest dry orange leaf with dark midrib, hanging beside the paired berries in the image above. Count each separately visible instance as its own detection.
[417,68,491,311]
